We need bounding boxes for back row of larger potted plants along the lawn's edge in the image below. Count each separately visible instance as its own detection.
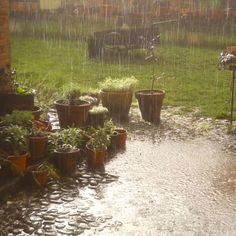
[55,75,165,128]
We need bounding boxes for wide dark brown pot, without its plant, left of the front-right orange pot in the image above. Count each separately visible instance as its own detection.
[54,149,80,175]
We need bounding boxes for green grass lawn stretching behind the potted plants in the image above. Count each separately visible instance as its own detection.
[12,31,231,117]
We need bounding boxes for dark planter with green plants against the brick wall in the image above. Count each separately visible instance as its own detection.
[0,67,34,116]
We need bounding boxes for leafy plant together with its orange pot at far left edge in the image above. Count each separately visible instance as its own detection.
[0,125,28,175]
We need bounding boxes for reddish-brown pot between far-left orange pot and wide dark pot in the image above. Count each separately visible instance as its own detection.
[29,136,48,160]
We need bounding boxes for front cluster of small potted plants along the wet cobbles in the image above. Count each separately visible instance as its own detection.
[0,111,126,185]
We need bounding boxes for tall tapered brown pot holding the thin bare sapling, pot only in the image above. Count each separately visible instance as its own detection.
[135,90,165,123]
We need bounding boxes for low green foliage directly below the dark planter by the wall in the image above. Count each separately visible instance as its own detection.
[0,110,33,127]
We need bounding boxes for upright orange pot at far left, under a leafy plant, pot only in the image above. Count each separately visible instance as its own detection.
[7,153,28,176]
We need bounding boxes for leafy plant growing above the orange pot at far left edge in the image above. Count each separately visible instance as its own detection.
[0,125,28,155]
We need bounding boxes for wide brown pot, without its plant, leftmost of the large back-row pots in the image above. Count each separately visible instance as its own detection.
[54,100,90,128]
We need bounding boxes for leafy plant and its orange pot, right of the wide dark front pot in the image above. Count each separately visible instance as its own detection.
[86,128,110,165]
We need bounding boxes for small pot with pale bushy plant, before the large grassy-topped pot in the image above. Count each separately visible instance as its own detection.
[87,106,108,128]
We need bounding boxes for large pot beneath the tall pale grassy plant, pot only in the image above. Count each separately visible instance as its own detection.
[100,91,133,120]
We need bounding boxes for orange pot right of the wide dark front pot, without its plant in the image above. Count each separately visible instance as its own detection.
[86,144,107,165]
